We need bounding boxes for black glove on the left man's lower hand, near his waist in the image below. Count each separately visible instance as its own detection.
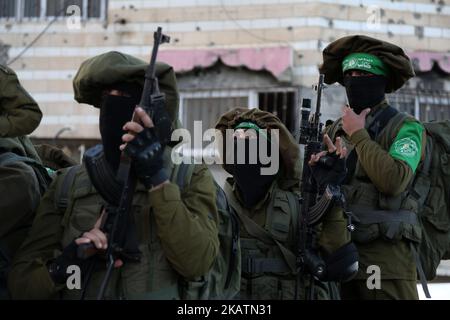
[47,240,86,284]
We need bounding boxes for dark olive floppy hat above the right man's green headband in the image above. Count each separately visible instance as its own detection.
[319,35,415,93]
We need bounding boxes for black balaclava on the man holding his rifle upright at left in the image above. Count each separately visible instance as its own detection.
[100,84,142,171]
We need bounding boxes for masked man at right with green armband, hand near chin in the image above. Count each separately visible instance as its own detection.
[320,36,424,299]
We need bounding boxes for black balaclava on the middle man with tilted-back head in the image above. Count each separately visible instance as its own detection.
[231,138,277,208]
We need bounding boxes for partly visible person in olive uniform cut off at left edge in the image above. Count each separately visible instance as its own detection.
[0,65,50,299]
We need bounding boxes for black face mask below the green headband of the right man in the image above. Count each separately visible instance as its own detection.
[344,75,387,114]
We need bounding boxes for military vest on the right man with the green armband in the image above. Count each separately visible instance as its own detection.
[328,107,421,243]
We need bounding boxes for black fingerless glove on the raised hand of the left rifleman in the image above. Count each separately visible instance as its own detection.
[125,128,168,189]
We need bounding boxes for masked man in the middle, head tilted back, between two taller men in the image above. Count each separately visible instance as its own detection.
[216,108,357,299]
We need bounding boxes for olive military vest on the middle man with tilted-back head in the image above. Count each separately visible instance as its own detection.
[224,182,328,300]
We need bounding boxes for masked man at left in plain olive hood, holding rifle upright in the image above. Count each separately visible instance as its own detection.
[8,52,219,299]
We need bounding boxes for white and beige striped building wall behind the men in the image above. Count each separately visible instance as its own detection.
[0,0,450,139]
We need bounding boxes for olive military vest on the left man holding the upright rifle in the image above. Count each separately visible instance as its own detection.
[55,166,192,300]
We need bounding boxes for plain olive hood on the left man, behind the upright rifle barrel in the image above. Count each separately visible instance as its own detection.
[73,51,179,127]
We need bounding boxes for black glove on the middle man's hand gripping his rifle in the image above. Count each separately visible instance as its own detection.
[309,152,347,190]
